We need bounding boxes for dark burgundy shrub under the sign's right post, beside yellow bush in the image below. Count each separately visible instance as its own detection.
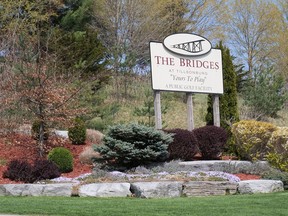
[193,126,227,160]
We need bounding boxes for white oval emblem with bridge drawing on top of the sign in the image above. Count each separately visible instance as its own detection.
[163,33,212,56]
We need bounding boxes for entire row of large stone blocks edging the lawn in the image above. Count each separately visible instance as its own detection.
[0,180,284,198]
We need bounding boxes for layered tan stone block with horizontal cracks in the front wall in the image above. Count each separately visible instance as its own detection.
[182,181,238,197]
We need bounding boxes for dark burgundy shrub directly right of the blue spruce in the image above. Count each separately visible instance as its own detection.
[165,128,199,160]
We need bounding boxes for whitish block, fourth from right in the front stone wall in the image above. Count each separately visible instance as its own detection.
[79,183,132,197]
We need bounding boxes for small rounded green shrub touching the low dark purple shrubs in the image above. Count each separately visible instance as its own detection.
[48,147,73,173]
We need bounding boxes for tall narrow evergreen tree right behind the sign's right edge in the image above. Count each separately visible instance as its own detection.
[206,42,239,132]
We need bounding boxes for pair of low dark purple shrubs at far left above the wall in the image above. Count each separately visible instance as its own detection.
[3,159,61,183]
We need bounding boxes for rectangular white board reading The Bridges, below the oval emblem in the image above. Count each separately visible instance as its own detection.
[150,42,223,94]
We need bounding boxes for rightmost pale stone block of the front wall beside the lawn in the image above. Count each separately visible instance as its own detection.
[238,180,284,194]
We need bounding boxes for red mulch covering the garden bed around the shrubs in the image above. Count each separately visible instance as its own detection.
[0,134,260,184]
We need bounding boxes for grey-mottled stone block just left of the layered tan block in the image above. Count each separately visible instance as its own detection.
[131,181,182,198]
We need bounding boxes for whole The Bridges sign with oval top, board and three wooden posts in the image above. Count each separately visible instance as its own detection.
[150,33,223,130]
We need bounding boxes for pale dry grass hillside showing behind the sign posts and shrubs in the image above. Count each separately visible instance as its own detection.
[100,77,288,129]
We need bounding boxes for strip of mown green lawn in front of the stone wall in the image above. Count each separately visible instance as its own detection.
[0,192,288,216]
